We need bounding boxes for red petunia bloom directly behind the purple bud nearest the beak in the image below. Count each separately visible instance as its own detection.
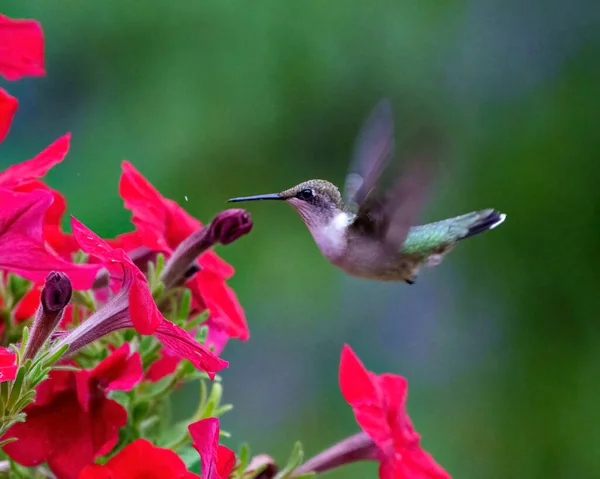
[119,161,249,341]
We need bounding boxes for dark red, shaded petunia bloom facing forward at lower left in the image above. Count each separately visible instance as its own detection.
[3,344,142,479]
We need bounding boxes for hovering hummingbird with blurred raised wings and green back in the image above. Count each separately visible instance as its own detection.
[228,100,506,284]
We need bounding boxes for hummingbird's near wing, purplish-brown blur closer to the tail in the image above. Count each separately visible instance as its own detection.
[350,135,437,254]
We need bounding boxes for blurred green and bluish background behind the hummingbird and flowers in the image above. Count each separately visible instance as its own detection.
[1,0,600,479]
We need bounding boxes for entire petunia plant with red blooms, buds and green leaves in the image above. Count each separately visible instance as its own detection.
[0,10,450,479]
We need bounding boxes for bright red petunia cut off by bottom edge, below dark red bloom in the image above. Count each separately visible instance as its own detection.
[79,439,200,479]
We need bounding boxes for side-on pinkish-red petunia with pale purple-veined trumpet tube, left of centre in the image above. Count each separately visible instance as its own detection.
[56,218,228,379]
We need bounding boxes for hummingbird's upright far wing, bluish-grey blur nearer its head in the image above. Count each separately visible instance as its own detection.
[344,99,394,210]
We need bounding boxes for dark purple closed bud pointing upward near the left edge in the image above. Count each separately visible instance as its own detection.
[25,271,73,359]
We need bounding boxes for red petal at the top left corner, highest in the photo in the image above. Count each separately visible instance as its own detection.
[0,15,46,80]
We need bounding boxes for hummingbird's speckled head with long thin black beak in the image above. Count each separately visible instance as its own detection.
[228,180,343,227]
